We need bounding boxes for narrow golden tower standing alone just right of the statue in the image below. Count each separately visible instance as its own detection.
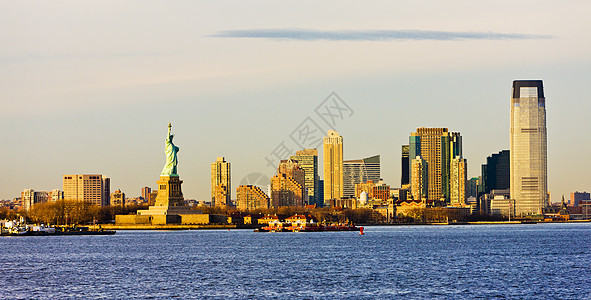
[211,157,232,206]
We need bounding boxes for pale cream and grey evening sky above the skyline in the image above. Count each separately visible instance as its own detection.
[0,0,591,202]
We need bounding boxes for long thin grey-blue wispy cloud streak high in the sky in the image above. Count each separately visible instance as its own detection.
[210,29,554,41]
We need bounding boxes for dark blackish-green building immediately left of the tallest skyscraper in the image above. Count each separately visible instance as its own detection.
[481,150,511,194]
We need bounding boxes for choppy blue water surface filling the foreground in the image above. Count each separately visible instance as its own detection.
[0,223,591,299]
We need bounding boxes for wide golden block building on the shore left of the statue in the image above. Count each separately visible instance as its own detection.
[63,174,111,206]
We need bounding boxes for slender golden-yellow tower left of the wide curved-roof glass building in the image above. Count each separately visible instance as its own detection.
[324,130,343,206]
